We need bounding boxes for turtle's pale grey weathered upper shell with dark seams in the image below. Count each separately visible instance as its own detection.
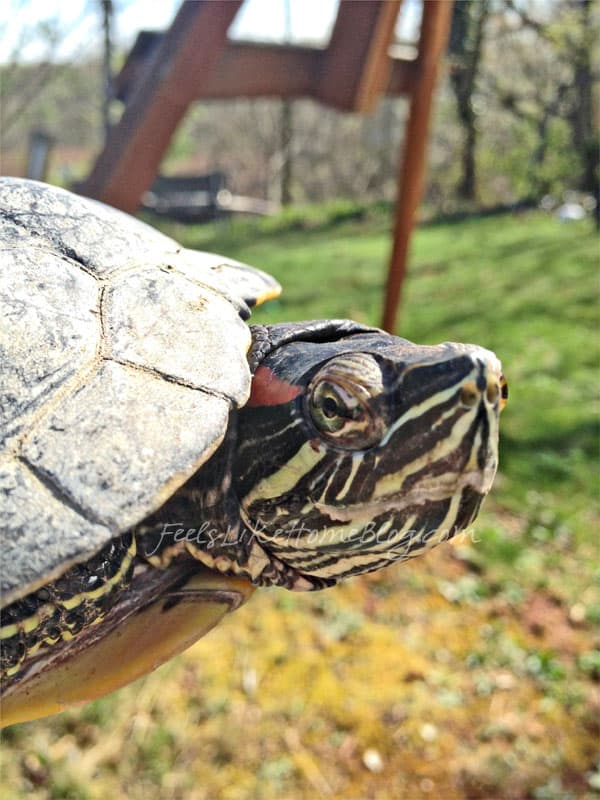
[0,178,279,604]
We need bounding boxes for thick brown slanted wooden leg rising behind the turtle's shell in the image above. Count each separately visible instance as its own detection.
[80,0,241,212]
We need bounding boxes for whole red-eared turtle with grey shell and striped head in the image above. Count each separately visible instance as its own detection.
[0,178,507,725]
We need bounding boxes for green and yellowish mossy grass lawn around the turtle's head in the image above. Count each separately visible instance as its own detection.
[1,208,600,800]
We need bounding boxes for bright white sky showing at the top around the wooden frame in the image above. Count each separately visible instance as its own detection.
[0,0,421,63]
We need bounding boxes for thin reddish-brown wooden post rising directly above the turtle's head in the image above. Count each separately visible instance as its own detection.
[382,0,453,332]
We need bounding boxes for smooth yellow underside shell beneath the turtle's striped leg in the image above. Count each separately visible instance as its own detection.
[1,569,253,726]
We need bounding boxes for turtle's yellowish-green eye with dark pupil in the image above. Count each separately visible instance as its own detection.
[308,380,379,450]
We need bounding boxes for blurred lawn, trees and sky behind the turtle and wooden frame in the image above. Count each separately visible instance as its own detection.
[0,0,600,800]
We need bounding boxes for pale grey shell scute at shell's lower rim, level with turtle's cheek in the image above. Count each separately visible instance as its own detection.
[22,361,229,531]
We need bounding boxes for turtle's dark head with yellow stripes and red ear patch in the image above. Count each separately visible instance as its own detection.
[234,321,506,589]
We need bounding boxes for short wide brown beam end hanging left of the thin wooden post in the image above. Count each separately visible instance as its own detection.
[316,0,401,113]
